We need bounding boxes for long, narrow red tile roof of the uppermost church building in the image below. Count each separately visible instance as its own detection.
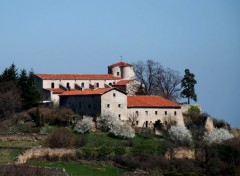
[36,74,121,80]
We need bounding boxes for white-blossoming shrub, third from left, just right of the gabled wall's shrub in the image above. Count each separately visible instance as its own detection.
[110,122,135,138]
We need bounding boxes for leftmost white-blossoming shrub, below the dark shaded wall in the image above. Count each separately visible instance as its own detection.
[74,117,94,134]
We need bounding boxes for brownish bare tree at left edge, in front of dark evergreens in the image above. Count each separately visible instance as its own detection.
[0,82,21,116]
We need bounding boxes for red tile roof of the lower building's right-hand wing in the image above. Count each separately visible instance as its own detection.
[127,96,181,108]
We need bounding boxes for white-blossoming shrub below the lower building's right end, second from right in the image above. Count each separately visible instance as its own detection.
[168,126,192,145]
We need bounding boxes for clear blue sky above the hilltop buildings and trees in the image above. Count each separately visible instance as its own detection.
[0,0,240,128]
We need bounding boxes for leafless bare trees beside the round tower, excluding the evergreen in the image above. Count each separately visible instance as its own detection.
[134,60,181,101]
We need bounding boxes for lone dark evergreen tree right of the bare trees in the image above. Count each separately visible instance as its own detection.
[181,69,197,104]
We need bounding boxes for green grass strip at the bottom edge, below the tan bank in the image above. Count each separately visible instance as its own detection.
[27,160,125,176]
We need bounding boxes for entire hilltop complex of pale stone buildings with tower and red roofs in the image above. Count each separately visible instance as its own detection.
[36,62,184,127]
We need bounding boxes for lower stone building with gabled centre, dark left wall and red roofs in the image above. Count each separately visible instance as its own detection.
[59,88,184,128]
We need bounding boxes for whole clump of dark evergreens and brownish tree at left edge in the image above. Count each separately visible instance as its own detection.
[0,64,41,117]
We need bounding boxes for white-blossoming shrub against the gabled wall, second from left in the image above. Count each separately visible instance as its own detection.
[97,113,119,132]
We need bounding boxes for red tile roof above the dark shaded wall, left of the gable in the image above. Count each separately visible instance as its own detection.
[60,88,114,96]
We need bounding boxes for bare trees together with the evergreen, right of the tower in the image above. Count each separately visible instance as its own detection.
[133,60,197,104]
